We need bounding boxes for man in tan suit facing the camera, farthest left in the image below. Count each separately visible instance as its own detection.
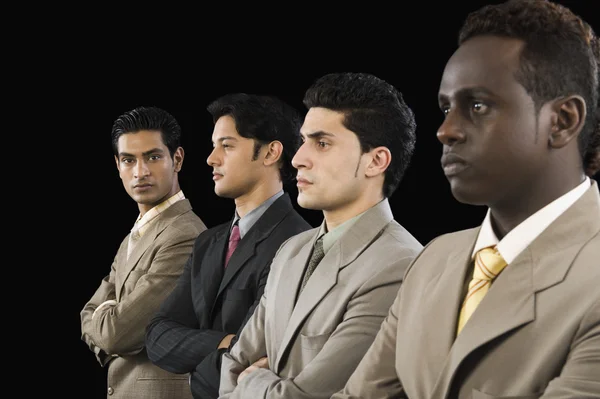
[81,107,206,399]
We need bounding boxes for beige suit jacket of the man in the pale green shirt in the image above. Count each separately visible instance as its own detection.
[220,200,422,399]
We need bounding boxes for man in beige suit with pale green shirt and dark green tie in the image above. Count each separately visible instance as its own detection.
[220,73,422,399]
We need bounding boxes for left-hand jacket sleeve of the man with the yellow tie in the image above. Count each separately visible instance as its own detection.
[331,291,406,399]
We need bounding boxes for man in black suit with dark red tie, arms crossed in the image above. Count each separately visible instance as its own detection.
[146,93,312,398]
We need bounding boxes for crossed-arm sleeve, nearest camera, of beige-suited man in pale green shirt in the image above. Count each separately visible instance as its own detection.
[221,257,413,399]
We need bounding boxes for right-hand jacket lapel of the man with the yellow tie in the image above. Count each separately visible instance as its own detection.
[432,183,600,398]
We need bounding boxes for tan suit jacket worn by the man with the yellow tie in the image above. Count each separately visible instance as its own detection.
[333,182,600,399]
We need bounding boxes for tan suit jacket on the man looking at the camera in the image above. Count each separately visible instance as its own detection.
[81,199,206,399]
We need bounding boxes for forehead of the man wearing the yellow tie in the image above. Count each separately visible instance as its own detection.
[439,36,523,97]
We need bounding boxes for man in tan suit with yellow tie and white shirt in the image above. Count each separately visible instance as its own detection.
[333,0,600,399]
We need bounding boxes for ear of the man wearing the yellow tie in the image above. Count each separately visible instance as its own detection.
[548,95,586,148]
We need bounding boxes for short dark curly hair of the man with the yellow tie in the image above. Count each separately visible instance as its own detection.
[458,0,600,176]
